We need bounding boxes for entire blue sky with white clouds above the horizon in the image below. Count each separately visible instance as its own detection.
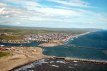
[0,0,107,29]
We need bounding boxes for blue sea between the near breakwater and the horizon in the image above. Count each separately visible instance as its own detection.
[43,30,107,60]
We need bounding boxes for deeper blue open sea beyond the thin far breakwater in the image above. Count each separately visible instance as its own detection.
[68,30,107,49]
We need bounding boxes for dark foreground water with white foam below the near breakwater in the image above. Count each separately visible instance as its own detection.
[11,58,107,71]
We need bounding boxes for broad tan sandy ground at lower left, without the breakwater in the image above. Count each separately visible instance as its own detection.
[0,47,45,71]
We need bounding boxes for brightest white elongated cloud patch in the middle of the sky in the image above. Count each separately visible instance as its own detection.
[36,7,80,18]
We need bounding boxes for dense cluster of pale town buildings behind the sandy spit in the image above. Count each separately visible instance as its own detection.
[25,33,74,42]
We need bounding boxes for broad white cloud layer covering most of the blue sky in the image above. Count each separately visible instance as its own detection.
[0,0,107,26]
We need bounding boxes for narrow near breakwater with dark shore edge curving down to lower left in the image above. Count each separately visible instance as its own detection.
[9,53,107,71]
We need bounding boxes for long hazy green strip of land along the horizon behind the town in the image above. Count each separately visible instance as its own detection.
[0,27,96,35]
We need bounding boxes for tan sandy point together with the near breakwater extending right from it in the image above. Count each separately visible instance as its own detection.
[0,47,107,71]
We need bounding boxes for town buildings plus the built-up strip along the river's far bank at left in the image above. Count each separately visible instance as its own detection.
[0,33,75,43]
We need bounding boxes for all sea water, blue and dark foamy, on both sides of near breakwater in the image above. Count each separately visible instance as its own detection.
[8,30,107,71]
